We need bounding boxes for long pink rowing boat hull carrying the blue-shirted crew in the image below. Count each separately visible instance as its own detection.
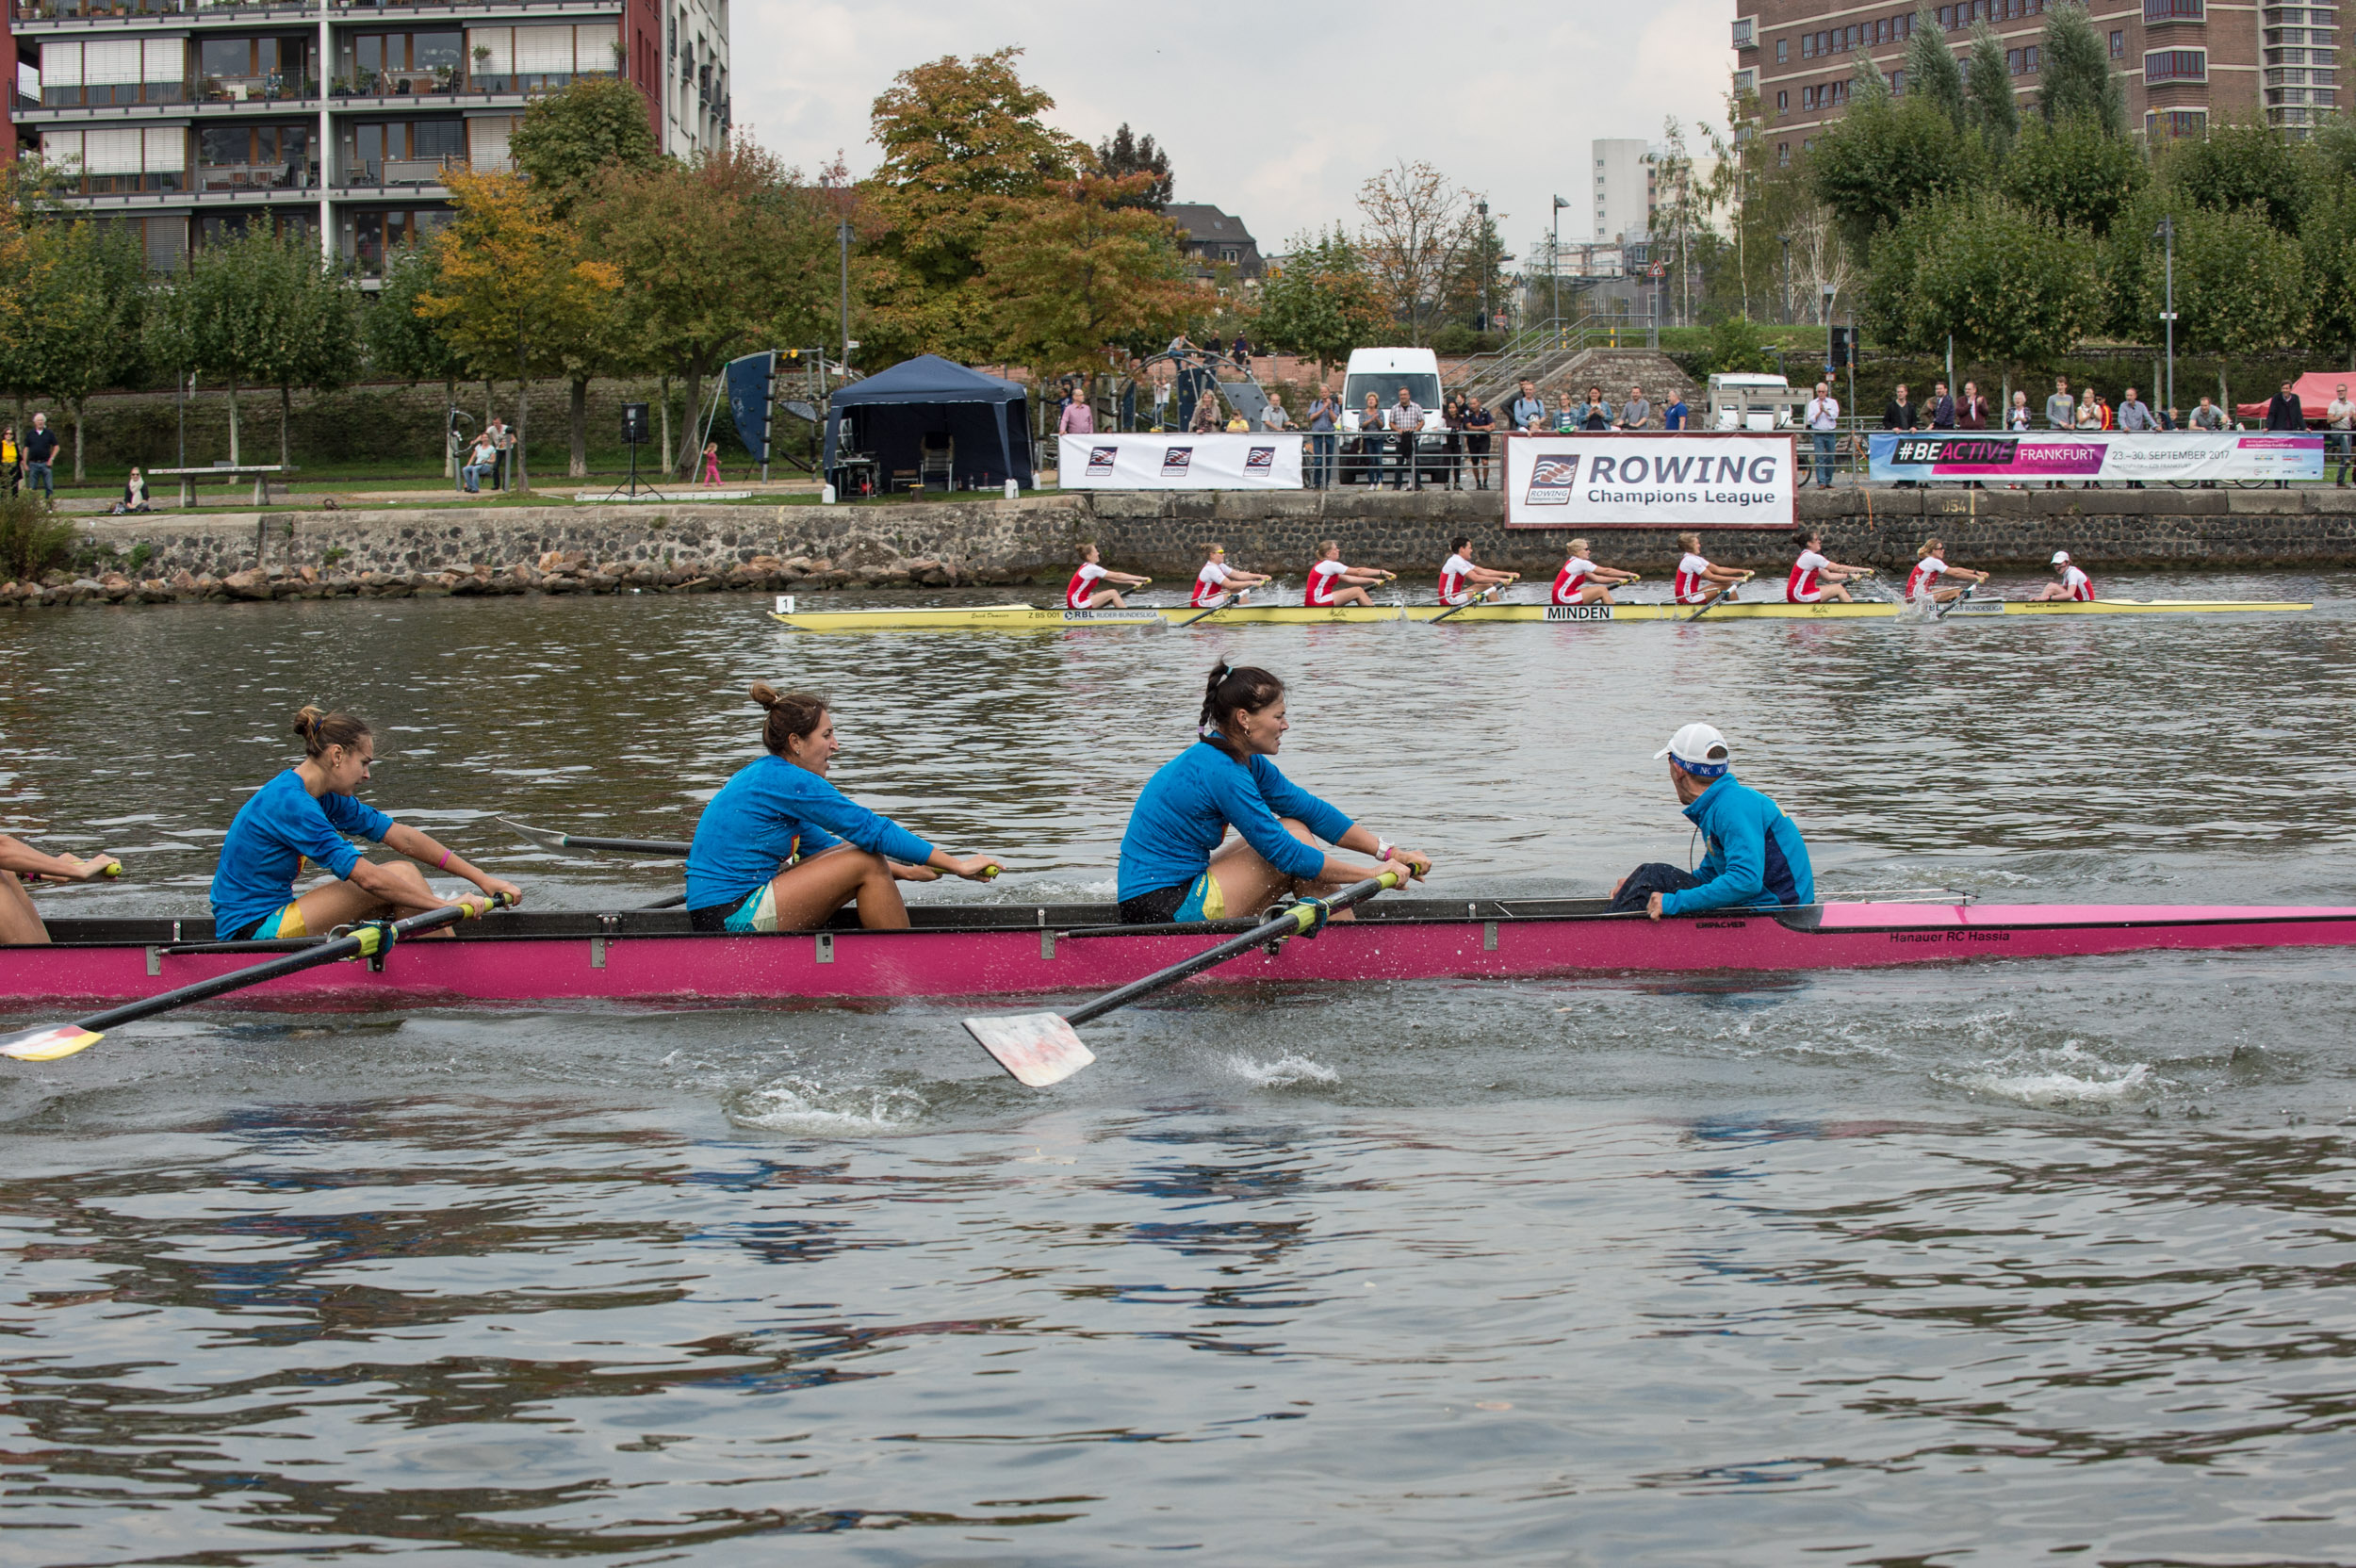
[0,897,2356,1010]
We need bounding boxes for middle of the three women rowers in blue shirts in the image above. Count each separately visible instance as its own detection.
[688,683,1004,932]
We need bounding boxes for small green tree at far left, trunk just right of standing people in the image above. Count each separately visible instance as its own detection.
[24,219,149,485]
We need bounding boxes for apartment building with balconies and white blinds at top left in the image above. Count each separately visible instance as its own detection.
[0,0,730,278]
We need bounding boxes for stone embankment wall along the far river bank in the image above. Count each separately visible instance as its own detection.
[0,490,2356,605]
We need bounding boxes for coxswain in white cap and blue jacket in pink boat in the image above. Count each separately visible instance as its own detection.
[1612,726,1817,921]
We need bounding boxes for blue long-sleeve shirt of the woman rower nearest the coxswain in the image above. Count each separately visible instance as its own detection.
[1117,742,1350,899]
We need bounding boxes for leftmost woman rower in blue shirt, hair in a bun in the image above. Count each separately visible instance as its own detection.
[212,709,523,941]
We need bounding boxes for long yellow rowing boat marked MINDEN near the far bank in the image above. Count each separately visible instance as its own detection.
[771,598,2314,631]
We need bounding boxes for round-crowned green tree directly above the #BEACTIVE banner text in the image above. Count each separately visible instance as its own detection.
[1866,190,2102,379]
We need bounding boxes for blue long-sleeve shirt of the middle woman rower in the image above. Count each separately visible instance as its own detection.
[688,754,933,908]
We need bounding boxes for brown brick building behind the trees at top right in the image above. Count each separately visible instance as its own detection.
[1734,0,2345,162]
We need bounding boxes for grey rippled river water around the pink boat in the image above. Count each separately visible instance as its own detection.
[0,575,2356,1566]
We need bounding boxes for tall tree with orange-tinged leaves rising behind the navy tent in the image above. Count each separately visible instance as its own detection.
[862,49,1091,363]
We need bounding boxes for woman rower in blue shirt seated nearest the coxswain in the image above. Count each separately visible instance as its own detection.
[1117,660,1432,925]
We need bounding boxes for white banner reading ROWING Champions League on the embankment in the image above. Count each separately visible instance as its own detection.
[1506,431,1793,528]
